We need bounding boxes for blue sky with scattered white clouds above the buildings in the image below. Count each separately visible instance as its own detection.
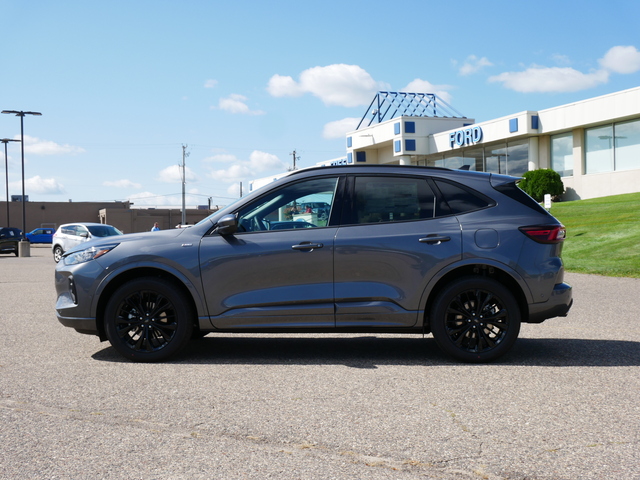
[0,0,640,207]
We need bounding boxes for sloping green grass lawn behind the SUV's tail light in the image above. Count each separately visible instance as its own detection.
[551,193,640,278]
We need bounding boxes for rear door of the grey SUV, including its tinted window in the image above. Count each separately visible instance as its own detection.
[334,175,462,328]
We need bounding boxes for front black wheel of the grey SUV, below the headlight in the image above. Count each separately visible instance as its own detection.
[104,277,193,362]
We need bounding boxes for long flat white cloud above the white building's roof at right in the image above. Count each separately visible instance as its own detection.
[489,66,609,93]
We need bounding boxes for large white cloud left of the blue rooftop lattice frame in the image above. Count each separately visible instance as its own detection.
[267,64,385,107]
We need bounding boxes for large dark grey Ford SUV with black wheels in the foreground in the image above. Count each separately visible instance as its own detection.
[55,165,572,362]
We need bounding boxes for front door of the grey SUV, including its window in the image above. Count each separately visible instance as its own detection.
[200,176,338,329]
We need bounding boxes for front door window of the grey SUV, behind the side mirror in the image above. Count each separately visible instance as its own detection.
[238,177,338,232]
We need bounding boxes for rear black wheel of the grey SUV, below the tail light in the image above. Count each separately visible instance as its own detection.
[430,277,521,363]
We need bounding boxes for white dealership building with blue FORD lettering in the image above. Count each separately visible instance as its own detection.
[322,87,640,200]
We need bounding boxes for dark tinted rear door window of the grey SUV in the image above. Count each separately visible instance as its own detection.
[354,177,435,224]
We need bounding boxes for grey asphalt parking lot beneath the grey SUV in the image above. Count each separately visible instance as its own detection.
[0,246,640,480]
